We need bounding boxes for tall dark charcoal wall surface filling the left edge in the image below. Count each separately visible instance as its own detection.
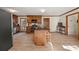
[0,9,12,51]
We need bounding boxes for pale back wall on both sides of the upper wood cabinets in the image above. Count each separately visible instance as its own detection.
[18,16,59,32]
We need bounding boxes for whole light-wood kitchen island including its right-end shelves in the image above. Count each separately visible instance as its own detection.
[33,30,50,46]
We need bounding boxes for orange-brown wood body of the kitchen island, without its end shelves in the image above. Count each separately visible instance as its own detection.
[34,30,48,46]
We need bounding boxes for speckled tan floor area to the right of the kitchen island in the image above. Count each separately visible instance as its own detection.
[51,33,79,51]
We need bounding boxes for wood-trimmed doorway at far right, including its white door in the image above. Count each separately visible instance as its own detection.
[66,12,79,39]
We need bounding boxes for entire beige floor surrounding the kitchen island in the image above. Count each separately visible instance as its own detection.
[9,32,79,51]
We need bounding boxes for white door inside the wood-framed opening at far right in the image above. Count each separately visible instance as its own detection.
[68,15,78,35]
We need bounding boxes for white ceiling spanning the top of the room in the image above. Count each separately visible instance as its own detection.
[2,7,76,16]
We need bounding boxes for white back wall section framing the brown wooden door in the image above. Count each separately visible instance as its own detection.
[41,16,59,32]
